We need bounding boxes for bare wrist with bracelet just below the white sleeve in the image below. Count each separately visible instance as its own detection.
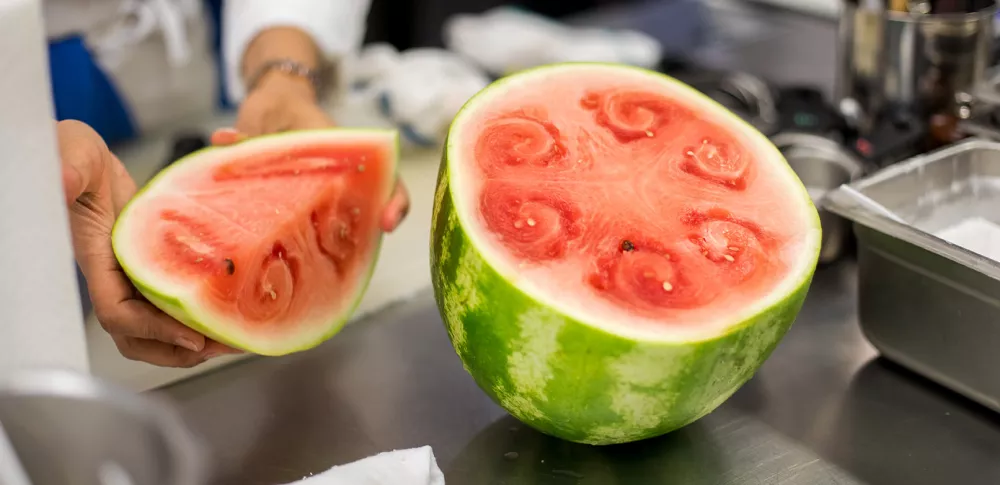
[240,27,322,99]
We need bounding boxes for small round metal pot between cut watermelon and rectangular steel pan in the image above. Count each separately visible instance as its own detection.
[771,132,865,264]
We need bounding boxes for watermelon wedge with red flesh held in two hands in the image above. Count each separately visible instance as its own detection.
[112,129,398,355]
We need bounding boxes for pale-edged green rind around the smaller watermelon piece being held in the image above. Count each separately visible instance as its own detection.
[111,127,399,356]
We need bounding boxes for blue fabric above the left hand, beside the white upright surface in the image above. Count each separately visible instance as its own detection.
[49,35,137,143]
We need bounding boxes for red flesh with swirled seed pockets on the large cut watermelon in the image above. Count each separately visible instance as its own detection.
[452,70,815,335]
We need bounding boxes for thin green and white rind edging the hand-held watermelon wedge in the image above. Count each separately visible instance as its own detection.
[111,127,399,356]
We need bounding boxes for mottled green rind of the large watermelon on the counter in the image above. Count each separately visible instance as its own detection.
[430,63,821,445]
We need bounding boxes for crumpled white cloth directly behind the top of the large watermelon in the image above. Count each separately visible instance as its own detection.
[444,6,663,75]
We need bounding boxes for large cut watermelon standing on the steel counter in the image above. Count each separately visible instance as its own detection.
[431,63,821,444]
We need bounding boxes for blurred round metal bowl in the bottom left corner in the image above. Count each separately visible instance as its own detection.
[0,371,205,485]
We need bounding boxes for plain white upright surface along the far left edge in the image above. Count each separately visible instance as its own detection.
[0,0,88,374]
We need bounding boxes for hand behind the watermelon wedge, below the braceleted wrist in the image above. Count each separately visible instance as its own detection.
[219,72,410,232]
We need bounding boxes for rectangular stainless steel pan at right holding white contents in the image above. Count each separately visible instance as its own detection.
[824,139,1000,411]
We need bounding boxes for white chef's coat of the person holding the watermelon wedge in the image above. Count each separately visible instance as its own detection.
[42,0,370,139]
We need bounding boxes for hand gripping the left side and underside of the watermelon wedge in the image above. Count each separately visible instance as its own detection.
[57,121,237,367]
